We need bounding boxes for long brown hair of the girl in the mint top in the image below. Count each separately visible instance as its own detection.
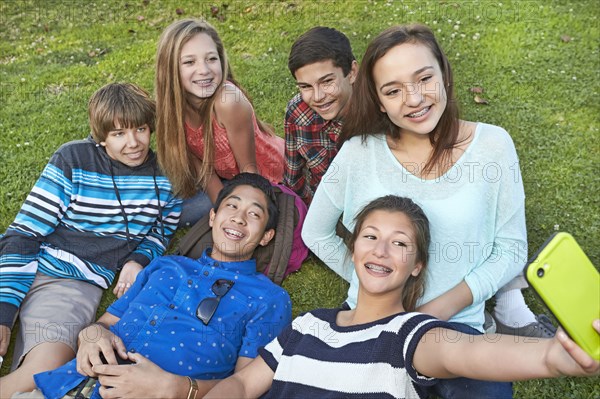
[337,24,459,174]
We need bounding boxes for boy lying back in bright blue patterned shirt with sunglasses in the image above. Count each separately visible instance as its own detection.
[21,173,291,398]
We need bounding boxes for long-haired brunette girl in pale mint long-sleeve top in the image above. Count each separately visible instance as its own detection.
[302,25,535,346]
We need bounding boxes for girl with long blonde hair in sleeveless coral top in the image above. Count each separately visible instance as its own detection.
[155,19,284,225]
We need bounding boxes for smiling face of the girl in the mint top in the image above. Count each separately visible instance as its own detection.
[373,43,447,138]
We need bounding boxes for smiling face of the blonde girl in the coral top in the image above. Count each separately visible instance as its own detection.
[179,33,223,98]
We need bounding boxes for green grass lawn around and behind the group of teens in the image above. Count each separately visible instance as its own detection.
[0,0,600,399]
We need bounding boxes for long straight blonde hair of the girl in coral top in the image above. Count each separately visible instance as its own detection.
[155,19,232,198]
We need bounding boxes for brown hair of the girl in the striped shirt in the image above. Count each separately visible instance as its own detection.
[348,195,431,312]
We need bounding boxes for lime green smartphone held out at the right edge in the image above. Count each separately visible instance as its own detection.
[525,232,600,360]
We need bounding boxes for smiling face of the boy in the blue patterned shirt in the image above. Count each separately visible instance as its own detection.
[209,185,275,262]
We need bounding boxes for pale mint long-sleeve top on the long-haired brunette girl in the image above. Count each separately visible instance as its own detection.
[302,123,527,331]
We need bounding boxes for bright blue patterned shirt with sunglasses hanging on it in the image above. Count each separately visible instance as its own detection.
[35,252,292,398]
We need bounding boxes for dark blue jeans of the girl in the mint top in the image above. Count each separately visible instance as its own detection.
[429,322,512,399]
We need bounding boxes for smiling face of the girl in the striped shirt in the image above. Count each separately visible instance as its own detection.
[352,210,422,295]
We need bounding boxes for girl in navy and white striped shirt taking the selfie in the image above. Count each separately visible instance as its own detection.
[206,196,600,398]
